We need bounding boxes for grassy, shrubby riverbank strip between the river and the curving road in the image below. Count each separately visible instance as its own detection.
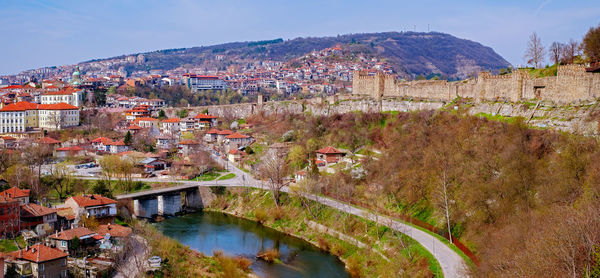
[208,188,443,277]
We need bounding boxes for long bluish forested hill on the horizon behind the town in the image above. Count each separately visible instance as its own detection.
[84,32,510,78]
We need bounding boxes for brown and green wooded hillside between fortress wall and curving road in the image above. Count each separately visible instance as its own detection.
[247,111,600,277]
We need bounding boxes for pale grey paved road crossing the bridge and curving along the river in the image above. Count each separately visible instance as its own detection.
[82,153,468,278]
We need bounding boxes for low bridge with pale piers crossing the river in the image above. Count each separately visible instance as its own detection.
[116,184,212,218]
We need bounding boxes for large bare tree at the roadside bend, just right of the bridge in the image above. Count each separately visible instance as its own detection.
[259,153,289,206]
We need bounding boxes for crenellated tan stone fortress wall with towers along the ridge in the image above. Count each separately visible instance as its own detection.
[352,65,600,104]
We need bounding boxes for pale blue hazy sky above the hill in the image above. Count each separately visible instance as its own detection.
[0,0,600,75]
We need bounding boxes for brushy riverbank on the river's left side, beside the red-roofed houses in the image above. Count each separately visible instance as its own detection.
[131,220,256,277]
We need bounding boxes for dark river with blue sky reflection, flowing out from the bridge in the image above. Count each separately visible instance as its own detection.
[155,212,349,278]
